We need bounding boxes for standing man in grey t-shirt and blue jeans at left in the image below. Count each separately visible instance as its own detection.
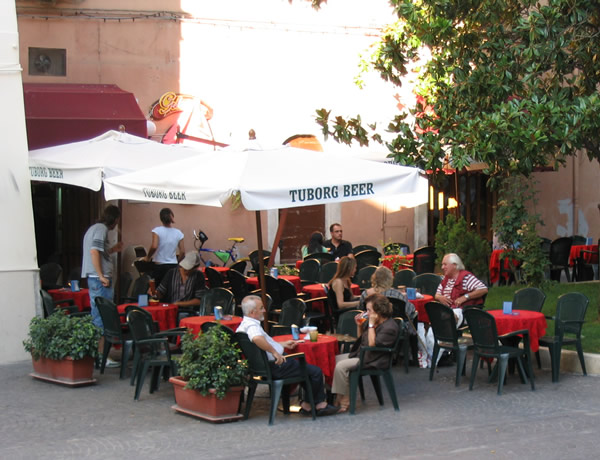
[81,205,123,367]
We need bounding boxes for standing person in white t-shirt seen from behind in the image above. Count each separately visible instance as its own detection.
[145,208,185,286]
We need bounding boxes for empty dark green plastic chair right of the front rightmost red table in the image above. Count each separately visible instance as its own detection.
[539,292,590,382]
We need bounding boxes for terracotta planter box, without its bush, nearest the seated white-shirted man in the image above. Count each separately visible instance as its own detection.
[169,377,244,422]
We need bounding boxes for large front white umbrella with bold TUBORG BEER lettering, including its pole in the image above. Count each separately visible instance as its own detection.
[104,147,427,328]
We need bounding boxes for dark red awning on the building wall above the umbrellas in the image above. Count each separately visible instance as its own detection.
[23,83,147,150]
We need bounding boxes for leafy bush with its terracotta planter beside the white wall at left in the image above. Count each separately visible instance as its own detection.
[23,311,101,386]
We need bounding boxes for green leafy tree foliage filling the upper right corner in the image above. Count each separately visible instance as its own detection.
[313,0,600,185]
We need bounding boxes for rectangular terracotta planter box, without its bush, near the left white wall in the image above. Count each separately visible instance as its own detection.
[31,356,96,385]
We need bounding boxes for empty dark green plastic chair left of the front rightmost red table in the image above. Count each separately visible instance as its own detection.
[463,308,535,395]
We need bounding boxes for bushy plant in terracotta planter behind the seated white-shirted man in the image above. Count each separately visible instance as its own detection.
[169,327,246,422]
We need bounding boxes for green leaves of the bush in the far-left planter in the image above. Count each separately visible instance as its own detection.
[23,311,101,360]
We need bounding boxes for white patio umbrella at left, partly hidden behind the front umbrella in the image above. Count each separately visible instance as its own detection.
[29,131,211,191]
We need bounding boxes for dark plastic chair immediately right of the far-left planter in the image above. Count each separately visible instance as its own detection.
[96,297,133,379]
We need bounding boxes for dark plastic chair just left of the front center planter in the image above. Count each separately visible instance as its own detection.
[127,309,183,401]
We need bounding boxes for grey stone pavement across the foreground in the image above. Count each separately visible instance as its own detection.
[0,362,600,460]
